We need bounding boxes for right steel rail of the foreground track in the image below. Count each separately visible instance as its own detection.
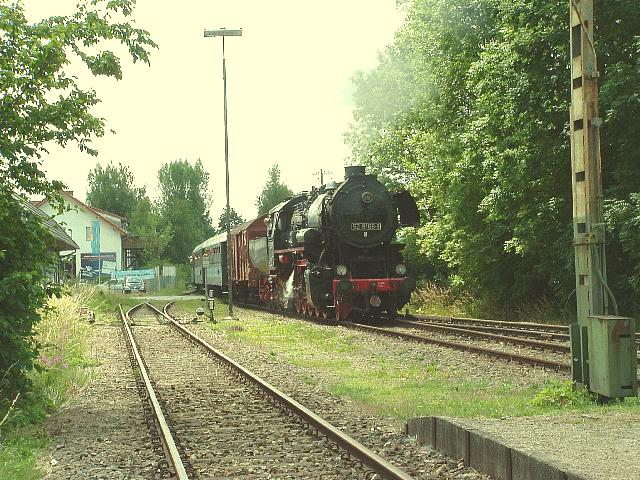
[153,303,413,480]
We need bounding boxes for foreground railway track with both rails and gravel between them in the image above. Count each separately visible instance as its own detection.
[122,304,412,480]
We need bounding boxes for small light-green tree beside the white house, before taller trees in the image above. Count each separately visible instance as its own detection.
[130,197,173,265]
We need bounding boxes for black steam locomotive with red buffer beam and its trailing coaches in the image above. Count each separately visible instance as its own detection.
[191,166,419,320]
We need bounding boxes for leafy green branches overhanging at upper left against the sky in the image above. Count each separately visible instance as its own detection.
[0,0,156,193]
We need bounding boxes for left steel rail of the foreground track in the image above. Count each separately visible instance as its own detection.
[119,303,189,480]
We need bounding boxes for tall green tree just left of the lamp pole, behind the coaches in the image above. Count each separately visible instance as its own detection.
[158,160,214,263]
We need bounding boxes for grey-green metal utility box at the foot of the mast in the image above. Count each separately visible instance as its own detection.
[589,315,638,398]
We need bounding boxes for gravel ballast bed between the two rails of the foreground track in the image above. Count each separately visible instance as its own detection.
[134,325,366,480]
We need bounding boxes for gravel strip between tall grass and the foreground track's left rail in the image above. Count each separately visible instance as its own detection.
[44,324,161,480]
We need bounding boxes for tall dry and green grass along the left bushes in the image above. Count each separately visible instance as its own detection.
[0,287,97,479]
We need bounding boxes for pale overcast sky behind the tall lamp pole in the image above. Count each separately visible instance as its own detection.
[24,0,402,223]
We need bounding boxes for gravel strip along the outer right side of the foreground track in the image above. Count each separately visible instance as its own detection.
[168,309,488,480]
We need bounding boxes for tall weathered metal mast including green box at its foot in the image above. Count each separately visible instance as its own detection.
[569,0,638,401]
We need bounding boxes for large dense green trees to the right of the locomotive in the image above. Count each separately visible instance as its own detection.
[346,0,640,312]
